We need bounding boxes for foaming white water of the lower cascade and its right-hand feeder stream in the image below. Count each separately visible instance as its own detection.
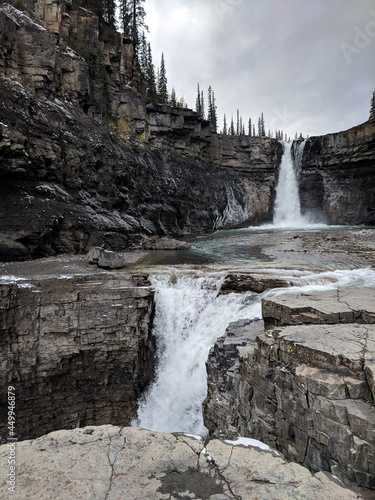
[132,269,375,435]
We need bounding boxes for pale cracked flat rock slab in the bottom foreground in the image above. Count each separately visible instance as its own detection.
[0,425,362,500]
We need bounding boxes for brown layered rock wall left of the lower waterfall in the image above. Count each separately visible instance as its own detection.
[0,273,154,440]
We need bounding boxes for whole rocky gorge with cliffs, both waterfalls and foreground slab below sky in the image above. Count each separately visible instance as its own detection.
[0,2,375,500]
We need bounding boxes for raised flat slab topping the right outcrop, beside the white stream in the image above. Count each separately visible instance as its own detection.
[262,288,375,328]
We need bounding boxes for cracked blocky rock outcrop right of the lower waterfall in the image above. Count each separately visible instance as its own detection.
[204,289,375,489]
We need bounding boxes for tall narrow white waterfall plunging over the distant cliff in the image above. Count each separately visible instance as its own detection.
[273,142,308,227]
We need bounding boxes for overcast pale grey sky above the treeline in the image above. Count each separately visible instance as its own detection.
[145,0,375,138]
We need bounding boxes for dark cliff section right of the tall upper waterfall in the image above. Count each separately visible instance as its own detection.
[299,121,375,224]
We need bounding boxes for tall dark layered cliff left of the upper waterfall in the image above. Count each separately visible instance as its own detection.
[0,2,281,260]
